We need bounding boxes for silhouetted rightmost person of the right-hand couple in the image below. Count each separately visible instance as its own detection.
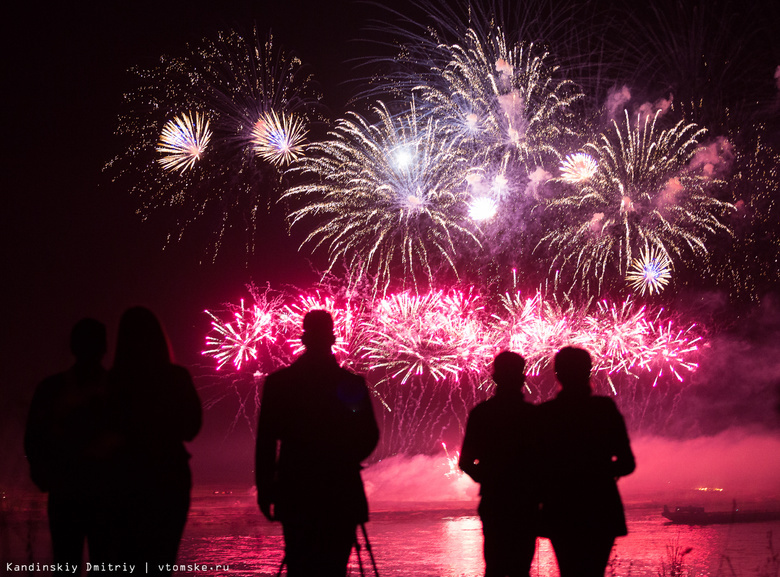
[539,347,635,577]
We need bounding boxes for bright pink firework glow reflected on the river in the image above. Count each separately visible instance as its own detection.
[179,490,780,577]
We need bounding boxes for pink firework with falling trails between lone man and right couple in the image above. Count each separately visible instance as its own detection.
[364,290,496,451]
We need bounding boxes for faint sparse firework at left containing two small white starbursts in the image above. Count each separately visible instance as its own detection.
[106,30,318,257]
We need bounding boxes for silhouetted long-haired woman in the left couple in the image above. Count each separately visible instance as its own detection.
[109,307,202,575]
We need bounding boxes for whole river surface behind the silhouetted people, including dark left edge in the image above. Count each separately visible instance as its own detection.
[0,489,780,577]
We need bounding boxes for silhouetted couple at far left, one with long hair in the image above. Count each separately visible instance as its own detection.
[25,307,201,574]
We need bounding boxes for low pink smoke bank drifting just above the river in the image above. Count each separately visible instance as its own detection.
[363,428,780,506]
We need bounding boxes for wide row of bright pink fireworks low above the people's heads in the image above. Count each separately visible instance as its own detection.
[203,287,703,454]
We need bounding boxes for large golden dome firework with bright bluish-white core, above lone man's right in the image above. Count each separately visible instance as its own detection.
[283,103,480,293]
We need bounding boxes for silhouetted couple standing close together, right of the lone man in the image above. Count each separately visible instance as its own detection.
[460,347,635,577]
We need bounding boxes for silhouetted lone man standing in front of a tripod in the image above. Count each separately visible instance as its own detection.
[255,310,379,577]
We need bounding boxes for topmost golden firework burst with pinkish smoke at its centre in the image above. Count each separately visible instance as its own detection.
[416,28,582,171]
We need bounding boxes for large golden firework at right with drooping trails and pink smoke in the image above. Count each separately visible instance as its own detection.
[537,112,734,294]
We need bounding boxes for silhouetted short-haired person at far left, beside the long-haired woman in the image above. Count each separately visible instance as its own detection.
[24,318,107,573]
